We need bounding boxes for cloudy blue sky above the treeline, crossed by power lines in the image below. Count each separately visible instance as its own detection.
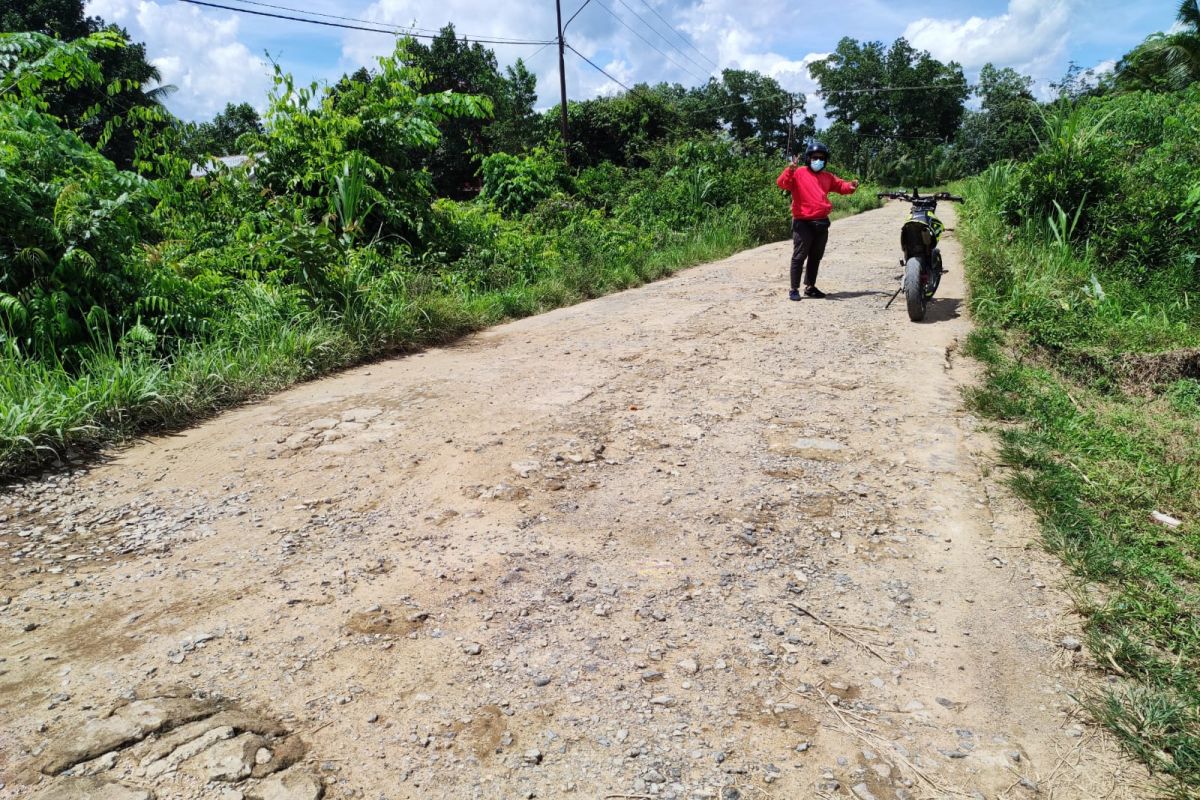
[86,0,1177,120]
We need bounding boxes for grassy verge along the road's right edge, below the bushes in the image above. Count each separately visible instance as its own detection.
[960,159,1200,798]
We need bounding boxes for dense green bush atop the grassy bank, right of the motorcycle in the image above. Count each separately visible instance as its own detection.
[1001,88,1200,300]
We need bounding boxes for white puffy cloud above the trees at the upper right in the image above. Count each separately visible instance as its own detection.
[904,0,1075,76]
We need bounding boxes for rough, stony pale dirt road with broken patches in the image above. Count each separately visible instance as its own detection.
[0,204,1144,800]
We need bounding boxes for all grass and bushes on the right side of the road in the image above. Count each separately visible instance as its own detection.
[960,1,1200,798]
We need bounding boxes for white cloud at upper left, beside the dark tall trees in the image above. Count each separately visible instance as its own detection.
[86,0,271,120]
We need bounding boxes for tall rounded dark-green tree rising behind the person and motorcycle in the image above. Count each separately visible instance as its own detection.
[809,37,970,180]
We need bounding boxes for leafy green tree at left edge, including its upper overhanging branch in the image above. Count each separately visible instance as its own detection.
[0,31,152,366]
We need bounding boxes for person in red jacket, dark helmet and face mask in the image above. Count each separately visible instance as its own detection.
[775,142,858,300]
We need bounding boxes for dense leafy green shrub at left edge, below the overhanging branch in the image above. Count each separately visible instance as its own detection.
[0,86,157,362]
